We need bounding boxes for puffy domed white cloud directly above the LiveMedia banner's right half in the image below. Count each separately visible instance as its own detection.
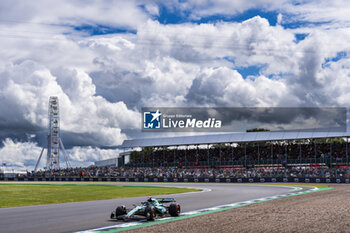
[186,67,292,107]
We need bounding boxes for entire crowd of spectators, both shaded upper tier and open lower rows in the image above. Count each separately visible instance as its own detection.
[22,141,350,178]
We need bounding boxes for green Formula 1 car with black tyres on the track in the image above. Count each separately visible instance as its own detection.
[111,197,181,221]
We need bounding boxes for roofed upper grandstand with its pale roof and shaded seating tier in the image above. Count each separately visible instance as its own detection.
[122,131,350,168]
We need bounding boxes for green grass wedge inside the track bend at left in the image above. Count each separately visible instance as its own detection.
[0,184,199,208]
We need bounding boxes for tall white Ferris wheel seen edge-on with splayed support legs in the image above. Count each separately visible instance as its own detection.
[34,96,71,171]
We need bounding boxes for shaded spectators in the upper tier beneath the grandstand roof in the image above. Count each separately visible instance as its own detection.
[130,141,350,166]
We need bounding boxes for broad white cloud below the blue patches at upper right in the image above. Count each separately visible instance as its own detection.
[137,16,299,73]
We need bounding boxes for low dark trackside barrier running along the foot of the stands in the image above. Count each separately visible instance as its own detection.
[0,177,350,184]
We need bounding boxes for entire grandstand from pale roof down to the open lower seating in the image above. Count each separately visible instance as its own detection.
[9,132,350,183]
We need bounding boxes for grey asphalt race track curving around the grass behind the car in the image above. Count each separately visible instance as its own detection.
[0,183,312,233]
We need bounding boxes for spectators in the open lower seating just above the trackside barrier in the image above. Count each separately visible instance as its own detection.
[27,166,350,178]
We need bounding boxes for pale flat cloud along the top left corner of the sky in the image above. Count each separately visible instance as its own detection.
[0,0,149,29]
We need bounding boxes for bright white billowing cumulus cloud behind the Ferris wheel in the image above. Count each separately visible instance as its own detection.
[0,61,140,146]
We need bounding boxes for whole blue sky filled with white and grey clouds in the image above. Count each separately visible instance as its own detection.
[0,0,350,170]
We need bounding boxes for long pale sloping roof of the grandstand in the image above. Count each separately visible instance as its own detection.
[121,131,350,148]
